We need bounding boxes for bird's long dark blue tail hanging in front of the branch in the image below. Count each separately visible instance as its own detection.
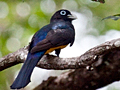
[10,51,45,89]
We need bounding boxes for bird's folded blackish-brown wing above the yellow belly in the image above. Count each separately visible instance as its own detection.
[31,29,74,53]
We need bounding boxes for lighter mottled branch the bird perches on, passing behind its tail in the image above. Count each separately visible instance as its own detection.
[0,38,120,71]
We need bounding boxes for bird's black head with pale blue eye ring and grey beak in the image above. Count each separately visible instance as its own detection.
[50,9,76,22]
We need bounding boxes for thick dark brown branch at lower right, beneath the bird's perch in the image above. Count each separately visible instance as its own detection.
[34,49,120,90]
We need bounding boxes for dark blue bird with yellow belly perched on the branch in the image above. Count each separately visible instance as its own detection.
[10,9,76,89]
